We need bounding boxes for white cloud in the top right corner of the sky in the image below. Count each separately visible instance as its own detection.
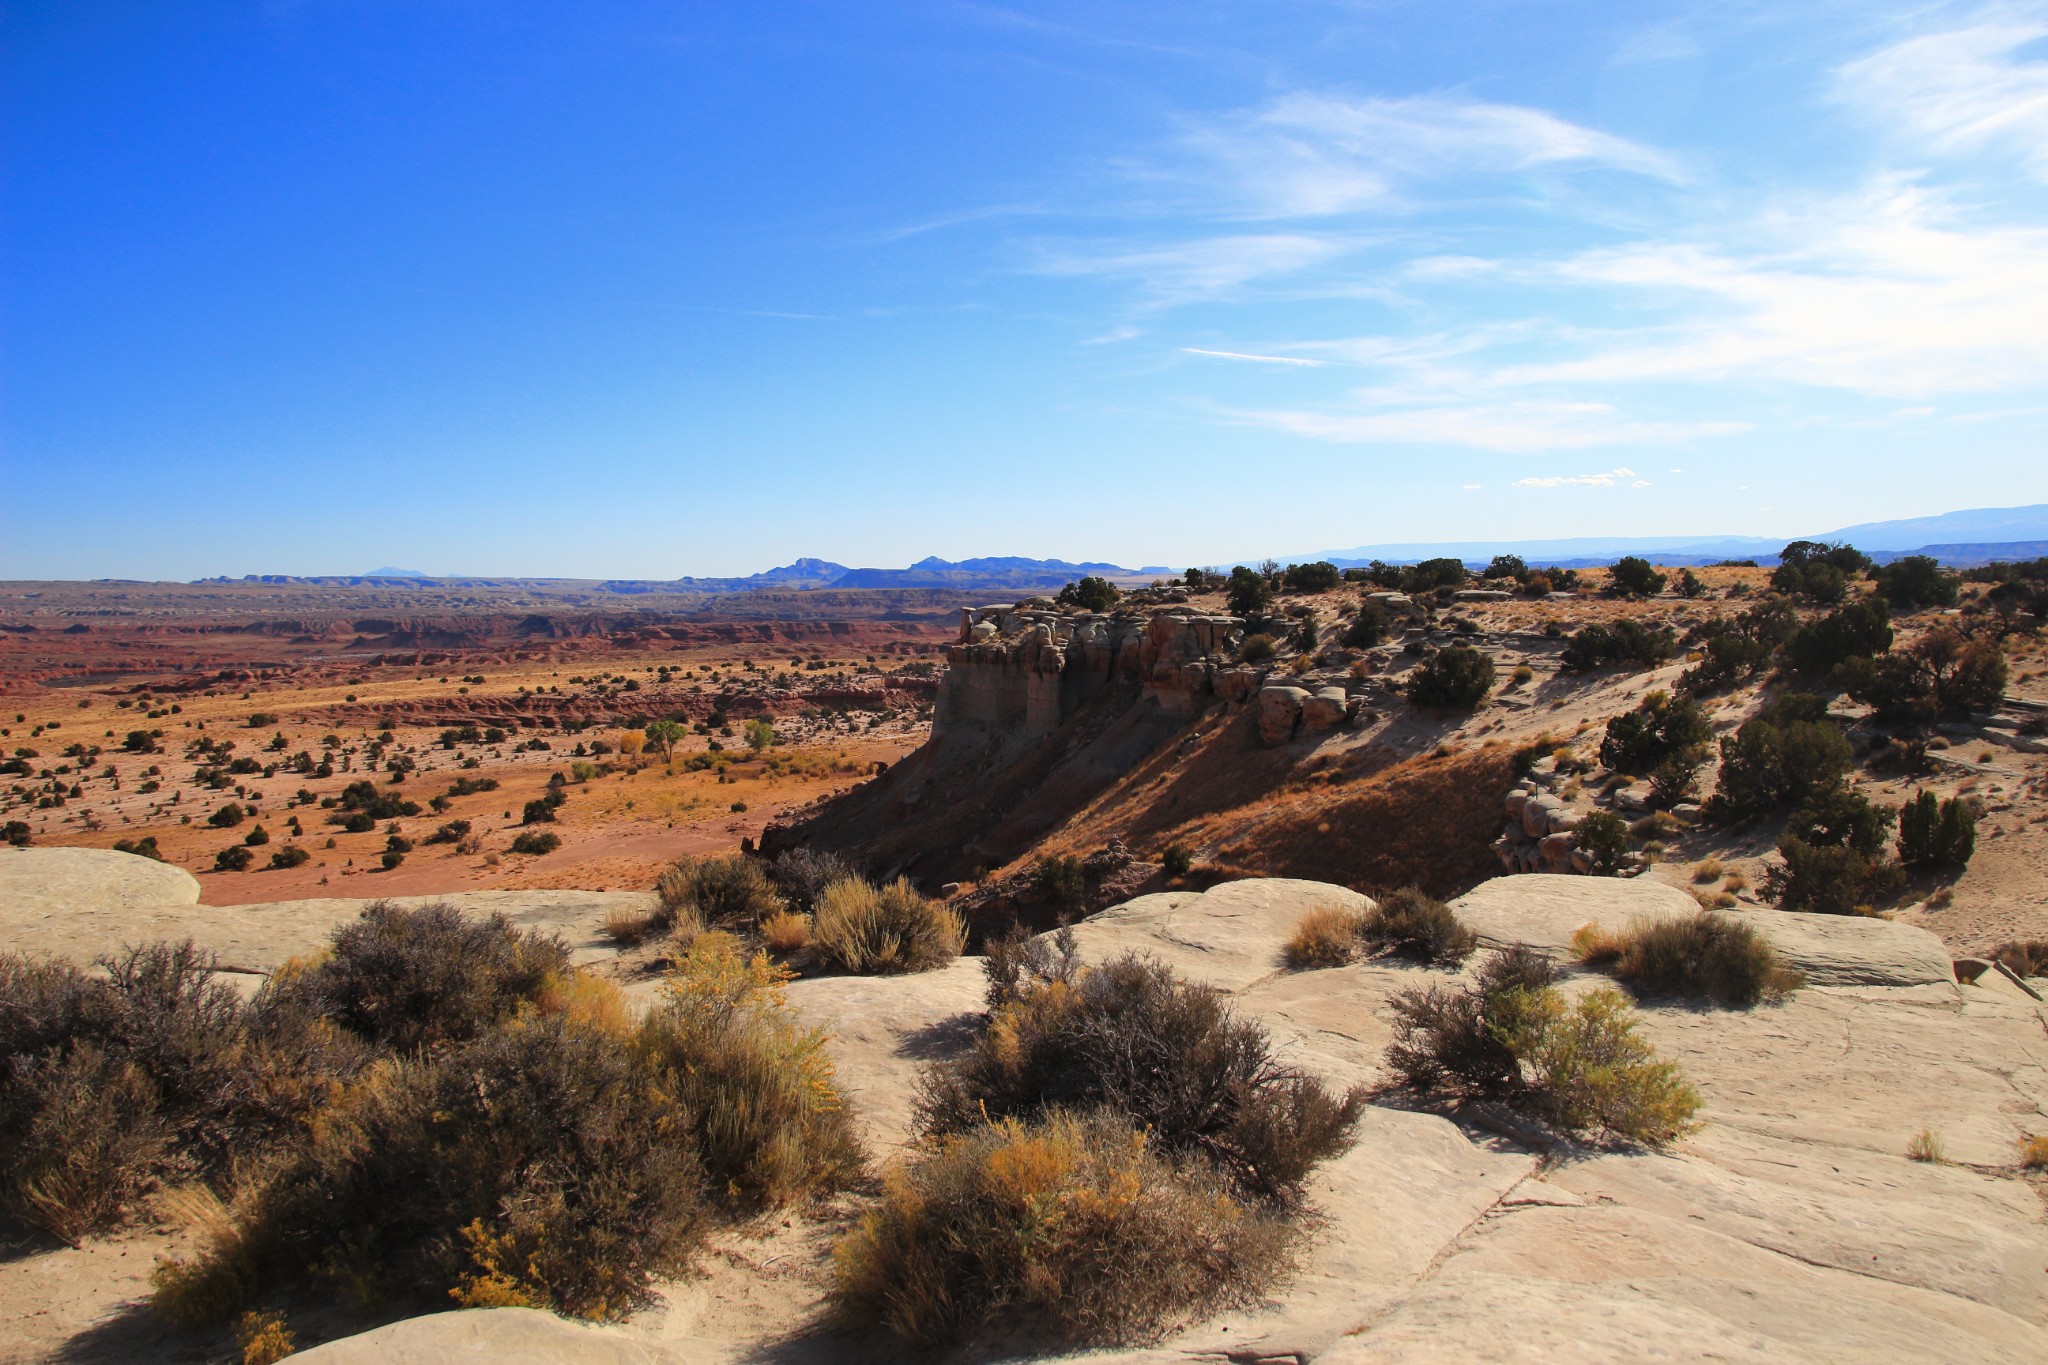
[1835,14,2048,180]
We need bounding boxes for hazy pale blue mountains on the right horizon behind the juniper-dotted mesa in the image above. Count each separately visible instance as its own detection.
[1294,503,2048,569]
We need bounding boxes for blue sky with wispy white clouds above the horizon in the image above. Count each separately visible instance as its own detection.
[0,0,2048,577]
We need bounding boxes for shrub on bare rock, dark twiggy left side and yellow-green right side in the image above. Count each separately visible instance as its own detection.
[1386,950,1700,1144]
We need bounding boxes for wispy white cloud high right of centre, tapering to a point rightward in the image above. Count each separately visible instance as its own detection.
[1188,94,1681,217]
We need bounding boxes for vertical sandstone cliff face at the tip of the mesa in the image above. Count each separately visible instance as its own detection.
[932,606,1245,739]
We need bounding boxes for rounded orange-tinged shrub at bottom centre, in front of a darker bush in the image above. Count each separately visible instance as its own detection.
[834,1113,1294,1347]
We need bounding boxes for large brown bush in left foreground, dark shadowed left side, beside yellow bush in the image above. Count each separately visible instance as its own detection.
[156,1017,702,1318]
